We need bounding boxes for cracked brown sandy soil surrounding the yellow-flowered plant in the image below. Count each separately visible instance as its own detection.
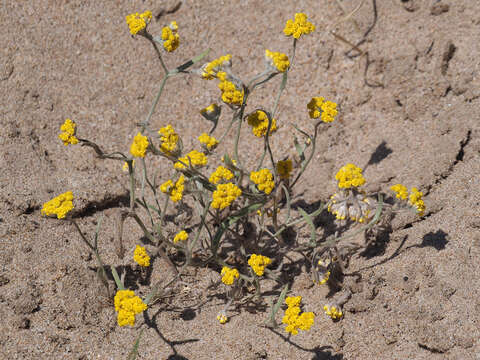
[0,0,480,360]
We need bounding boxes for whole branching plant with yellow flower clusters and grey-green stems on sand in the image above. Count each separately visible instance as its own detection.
[41,7,434,346]
